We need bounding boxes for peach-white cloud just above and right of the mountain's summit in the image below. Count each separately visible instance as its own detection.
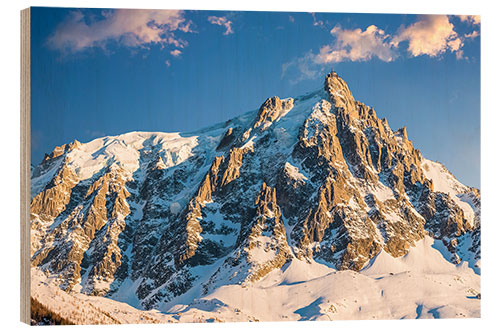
[314,25,397,64]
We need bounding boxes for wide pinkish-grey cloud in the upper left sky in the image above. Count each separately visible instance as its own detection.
[47,9,192,53]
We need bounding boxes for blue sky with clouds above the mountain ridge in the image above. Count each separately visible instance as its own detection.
[31,8,481,187]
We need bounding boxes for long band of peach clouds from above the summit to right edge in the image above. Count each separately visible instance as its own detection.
[282,15,481,84]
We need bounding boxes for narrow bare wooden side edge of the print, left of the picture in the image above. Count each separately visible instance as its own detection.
[20,8,31,325]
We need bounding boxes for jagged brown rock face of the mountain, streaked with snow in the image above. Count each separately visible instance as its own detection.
[31,72,480,309]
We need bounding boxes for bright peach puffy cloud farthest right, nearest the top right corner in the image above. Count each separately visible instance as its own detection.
[391,15,463,57]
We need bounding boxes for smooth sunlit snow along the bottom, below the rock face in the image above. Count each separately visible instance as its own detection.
[32,237,480,324]
